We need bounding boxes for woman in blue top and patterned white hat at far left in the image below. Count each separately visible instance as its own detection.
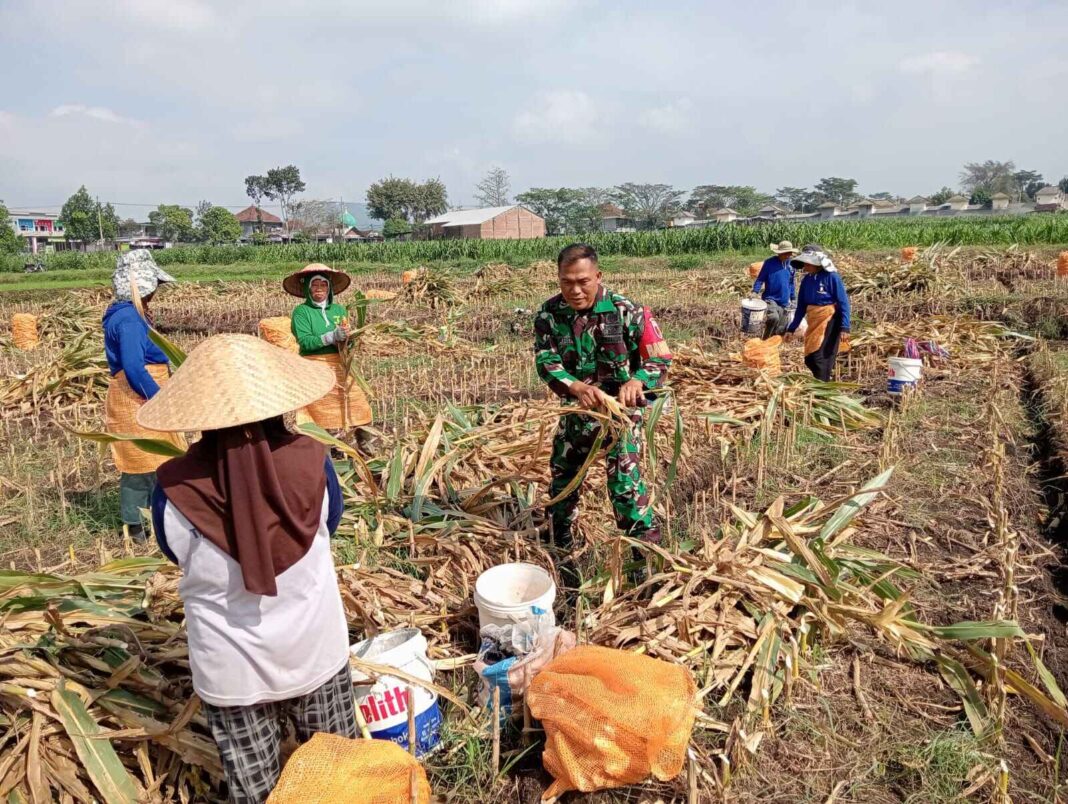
[103,249,185,541]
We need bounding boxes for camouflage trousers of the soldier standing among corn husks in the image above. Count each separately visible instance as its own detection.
[549,408,660,547]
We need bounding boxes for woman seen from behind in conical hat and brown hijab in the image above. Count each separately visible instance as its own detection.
[138,335,357,804]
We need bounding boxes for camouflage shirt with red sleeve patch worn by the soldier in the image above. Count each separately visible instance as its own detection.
[534,286,671,398]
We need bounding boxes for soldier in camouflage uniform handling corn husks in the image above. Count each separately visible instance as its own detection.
[534,243,671,547]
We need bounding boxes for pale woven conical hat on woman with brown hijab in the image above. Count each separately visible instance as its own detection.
[137,335,334,432]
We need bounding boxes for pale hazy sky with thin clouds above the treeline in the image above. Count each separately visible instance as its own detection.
[0,0,1068,220]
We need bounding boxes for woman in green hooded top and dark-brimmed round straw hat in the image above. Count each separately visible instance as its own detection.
[282,263,371,430]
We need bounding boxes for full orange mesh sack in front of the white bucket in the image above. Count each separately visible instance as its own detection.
[528,645,697,799]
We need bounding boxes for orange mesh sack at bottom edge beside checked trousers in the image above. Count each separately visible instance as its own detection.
[267,735,430,804]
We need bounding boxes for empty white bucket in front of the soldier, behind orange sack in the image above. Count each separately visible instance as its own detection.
[474,564,556,631]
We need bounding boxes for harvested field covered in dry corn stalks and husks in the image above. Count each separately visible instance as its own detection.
[0,247,1068,804]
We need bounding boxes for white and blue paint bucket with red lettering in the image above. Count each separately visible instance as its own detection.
[349,628,441,756]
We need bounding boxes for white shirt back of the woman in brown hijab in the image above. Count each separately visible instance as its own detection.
[163,491,348,706]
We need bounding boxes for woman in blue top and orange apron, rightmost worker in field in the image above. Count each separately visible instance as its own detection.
[786,246,849,382]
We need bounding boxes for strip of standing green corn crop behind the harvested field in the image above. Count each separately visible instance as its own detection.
[6,215,1068,270]
